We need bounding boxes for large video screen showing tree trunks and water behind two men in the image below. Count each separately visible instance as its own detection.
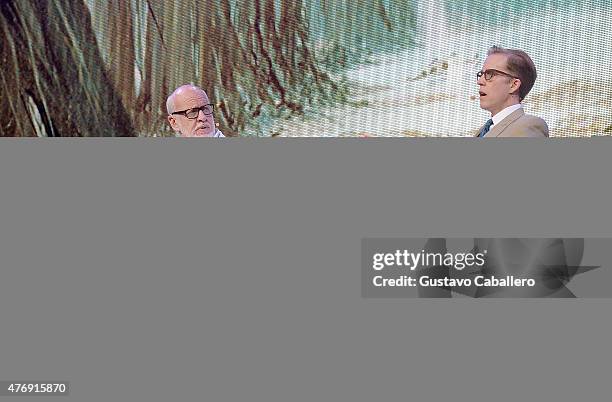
[0,0,612,137]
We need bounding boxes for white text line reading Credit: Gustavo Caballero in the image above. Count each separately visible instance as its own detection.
[372,275,536,287]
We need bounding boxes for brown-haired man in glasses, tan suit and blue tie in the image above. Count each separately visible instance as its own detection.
[476,46,548,138]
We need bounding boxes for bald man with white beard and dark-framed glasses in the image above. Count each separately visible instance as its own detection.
[166,85,225,138]
